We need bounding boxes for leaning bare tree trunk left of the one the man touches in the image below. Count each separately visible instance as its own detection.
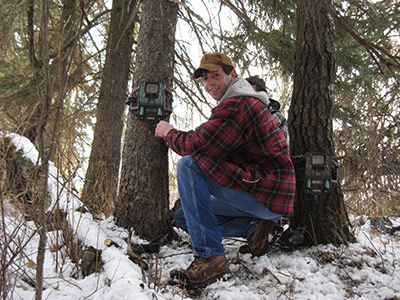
[82,0,136,217]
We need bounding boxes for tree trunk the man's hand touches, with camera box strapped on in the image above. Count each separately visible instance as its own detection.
[115,0,178,241]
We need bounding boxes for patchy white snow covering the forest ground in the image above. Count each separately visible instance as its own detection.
[0,135,400,300]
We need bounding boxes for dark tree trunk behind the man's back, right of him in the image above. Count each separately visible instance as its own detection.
[289,0,353,245]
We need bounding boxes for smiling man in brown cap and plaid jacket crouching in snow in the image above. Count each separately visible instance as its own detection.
[155,53,296,289]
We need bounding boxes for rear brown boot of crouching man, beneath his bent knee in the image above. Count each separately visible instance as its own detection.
[239,220,276,256]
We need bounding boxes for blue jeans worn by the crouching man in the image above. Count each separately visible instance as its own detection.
[175,156,282,257]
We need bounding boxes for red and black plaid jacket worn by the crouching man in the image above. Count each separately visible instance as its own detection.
[165,97,296,216]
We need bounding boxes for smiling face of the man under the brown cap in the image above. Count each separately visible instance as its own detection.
[201,67,236,100]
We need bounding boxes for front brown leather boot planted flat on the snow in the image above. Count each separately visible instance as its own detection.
[169,255,232,290]
